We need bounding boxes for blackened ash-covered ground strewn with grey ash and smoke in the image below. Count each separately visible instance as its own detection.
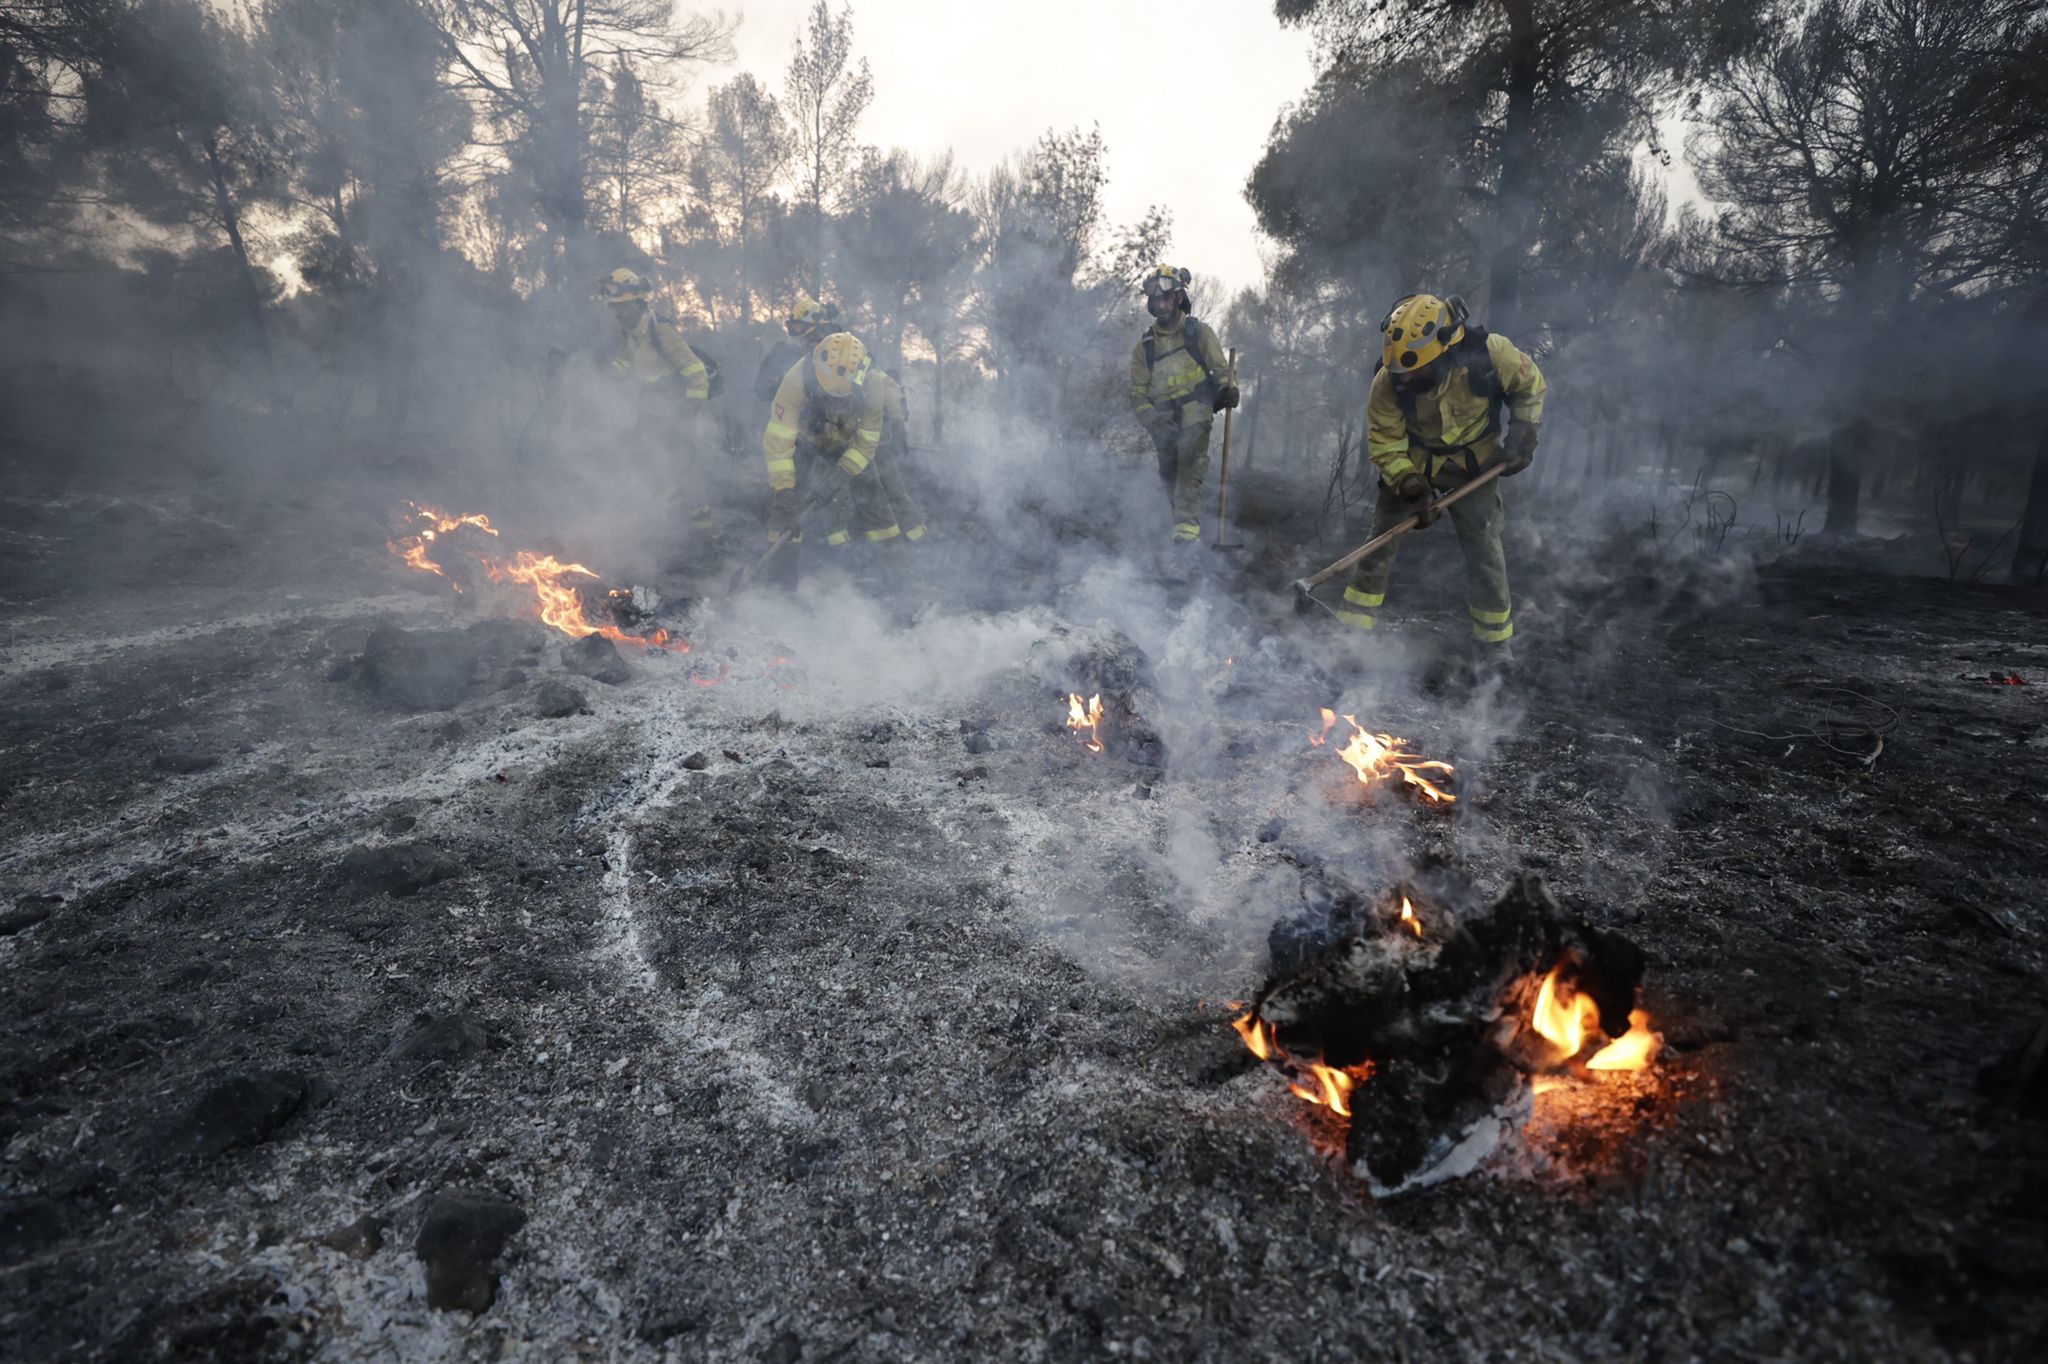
[0,471,2048,1362]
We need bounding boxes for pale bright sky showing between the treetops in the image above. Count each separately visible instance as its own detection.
[729,0,1315,309]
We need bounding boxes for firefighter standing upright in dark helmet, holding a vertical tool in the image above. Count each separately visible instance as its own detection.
[1130,264,1237,547]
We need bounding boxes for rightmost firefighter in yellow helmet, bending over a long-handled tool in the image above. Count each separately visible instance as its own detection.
[1337,293,1546,662]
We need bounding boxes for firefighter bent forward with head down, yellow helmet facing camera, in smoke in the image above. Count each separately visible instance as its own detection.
[762,332,903,584]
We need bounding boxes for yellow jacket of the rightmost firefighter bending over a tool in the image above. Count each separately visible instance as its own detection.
[1366,334,1548,483]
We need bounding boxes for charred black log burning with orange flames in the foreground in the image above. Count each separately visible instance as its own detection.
[1233,868,1659,1196]
